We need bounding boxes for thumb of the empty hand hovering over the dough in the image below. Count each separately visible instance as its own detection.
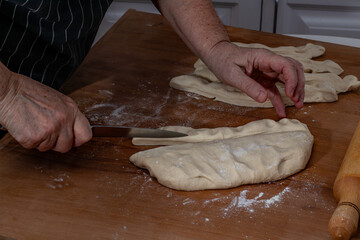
[227,69,267,103]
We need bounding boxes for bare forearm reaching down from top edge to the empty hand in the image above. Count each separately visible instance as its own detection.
[158,0,229,62]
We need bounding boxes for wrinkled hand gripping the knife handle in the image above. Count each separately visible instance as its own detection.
[0,62,92,153]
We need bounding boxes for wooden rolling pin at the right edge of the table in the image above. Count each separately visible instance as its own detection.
[329,122,360,240]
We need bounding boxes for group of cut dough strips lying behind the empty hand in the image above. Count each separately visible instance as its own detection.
[170,43,360,108]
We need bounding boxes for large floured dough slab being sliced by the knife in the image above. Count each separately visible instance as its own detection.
[130,119,313,191]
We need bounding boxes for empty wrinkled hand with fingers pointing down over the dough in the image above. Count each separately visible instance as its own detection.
[205,41,305,118]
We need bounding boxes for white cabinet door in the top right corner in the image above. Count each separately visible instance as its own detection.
[276,0,360,38]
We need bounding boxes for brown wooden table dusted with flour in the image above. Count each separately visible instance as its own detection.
[0,11,360,240]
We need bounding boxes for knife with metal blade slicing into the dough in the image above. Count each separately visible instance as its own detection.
[0,125,188,138]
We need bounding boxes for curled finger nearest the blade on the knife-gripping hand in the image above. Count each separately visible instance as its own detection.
[74,112,92,147]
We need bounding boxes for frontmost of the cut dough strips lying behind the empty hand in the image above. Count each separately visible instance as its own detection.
[170,73,360,108]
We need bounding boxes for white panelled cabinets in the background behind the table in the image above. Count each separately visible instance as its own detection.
[95,0,360,45]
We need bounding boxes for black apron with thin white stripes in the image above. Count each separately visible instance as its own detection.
[0,0,112,89]
